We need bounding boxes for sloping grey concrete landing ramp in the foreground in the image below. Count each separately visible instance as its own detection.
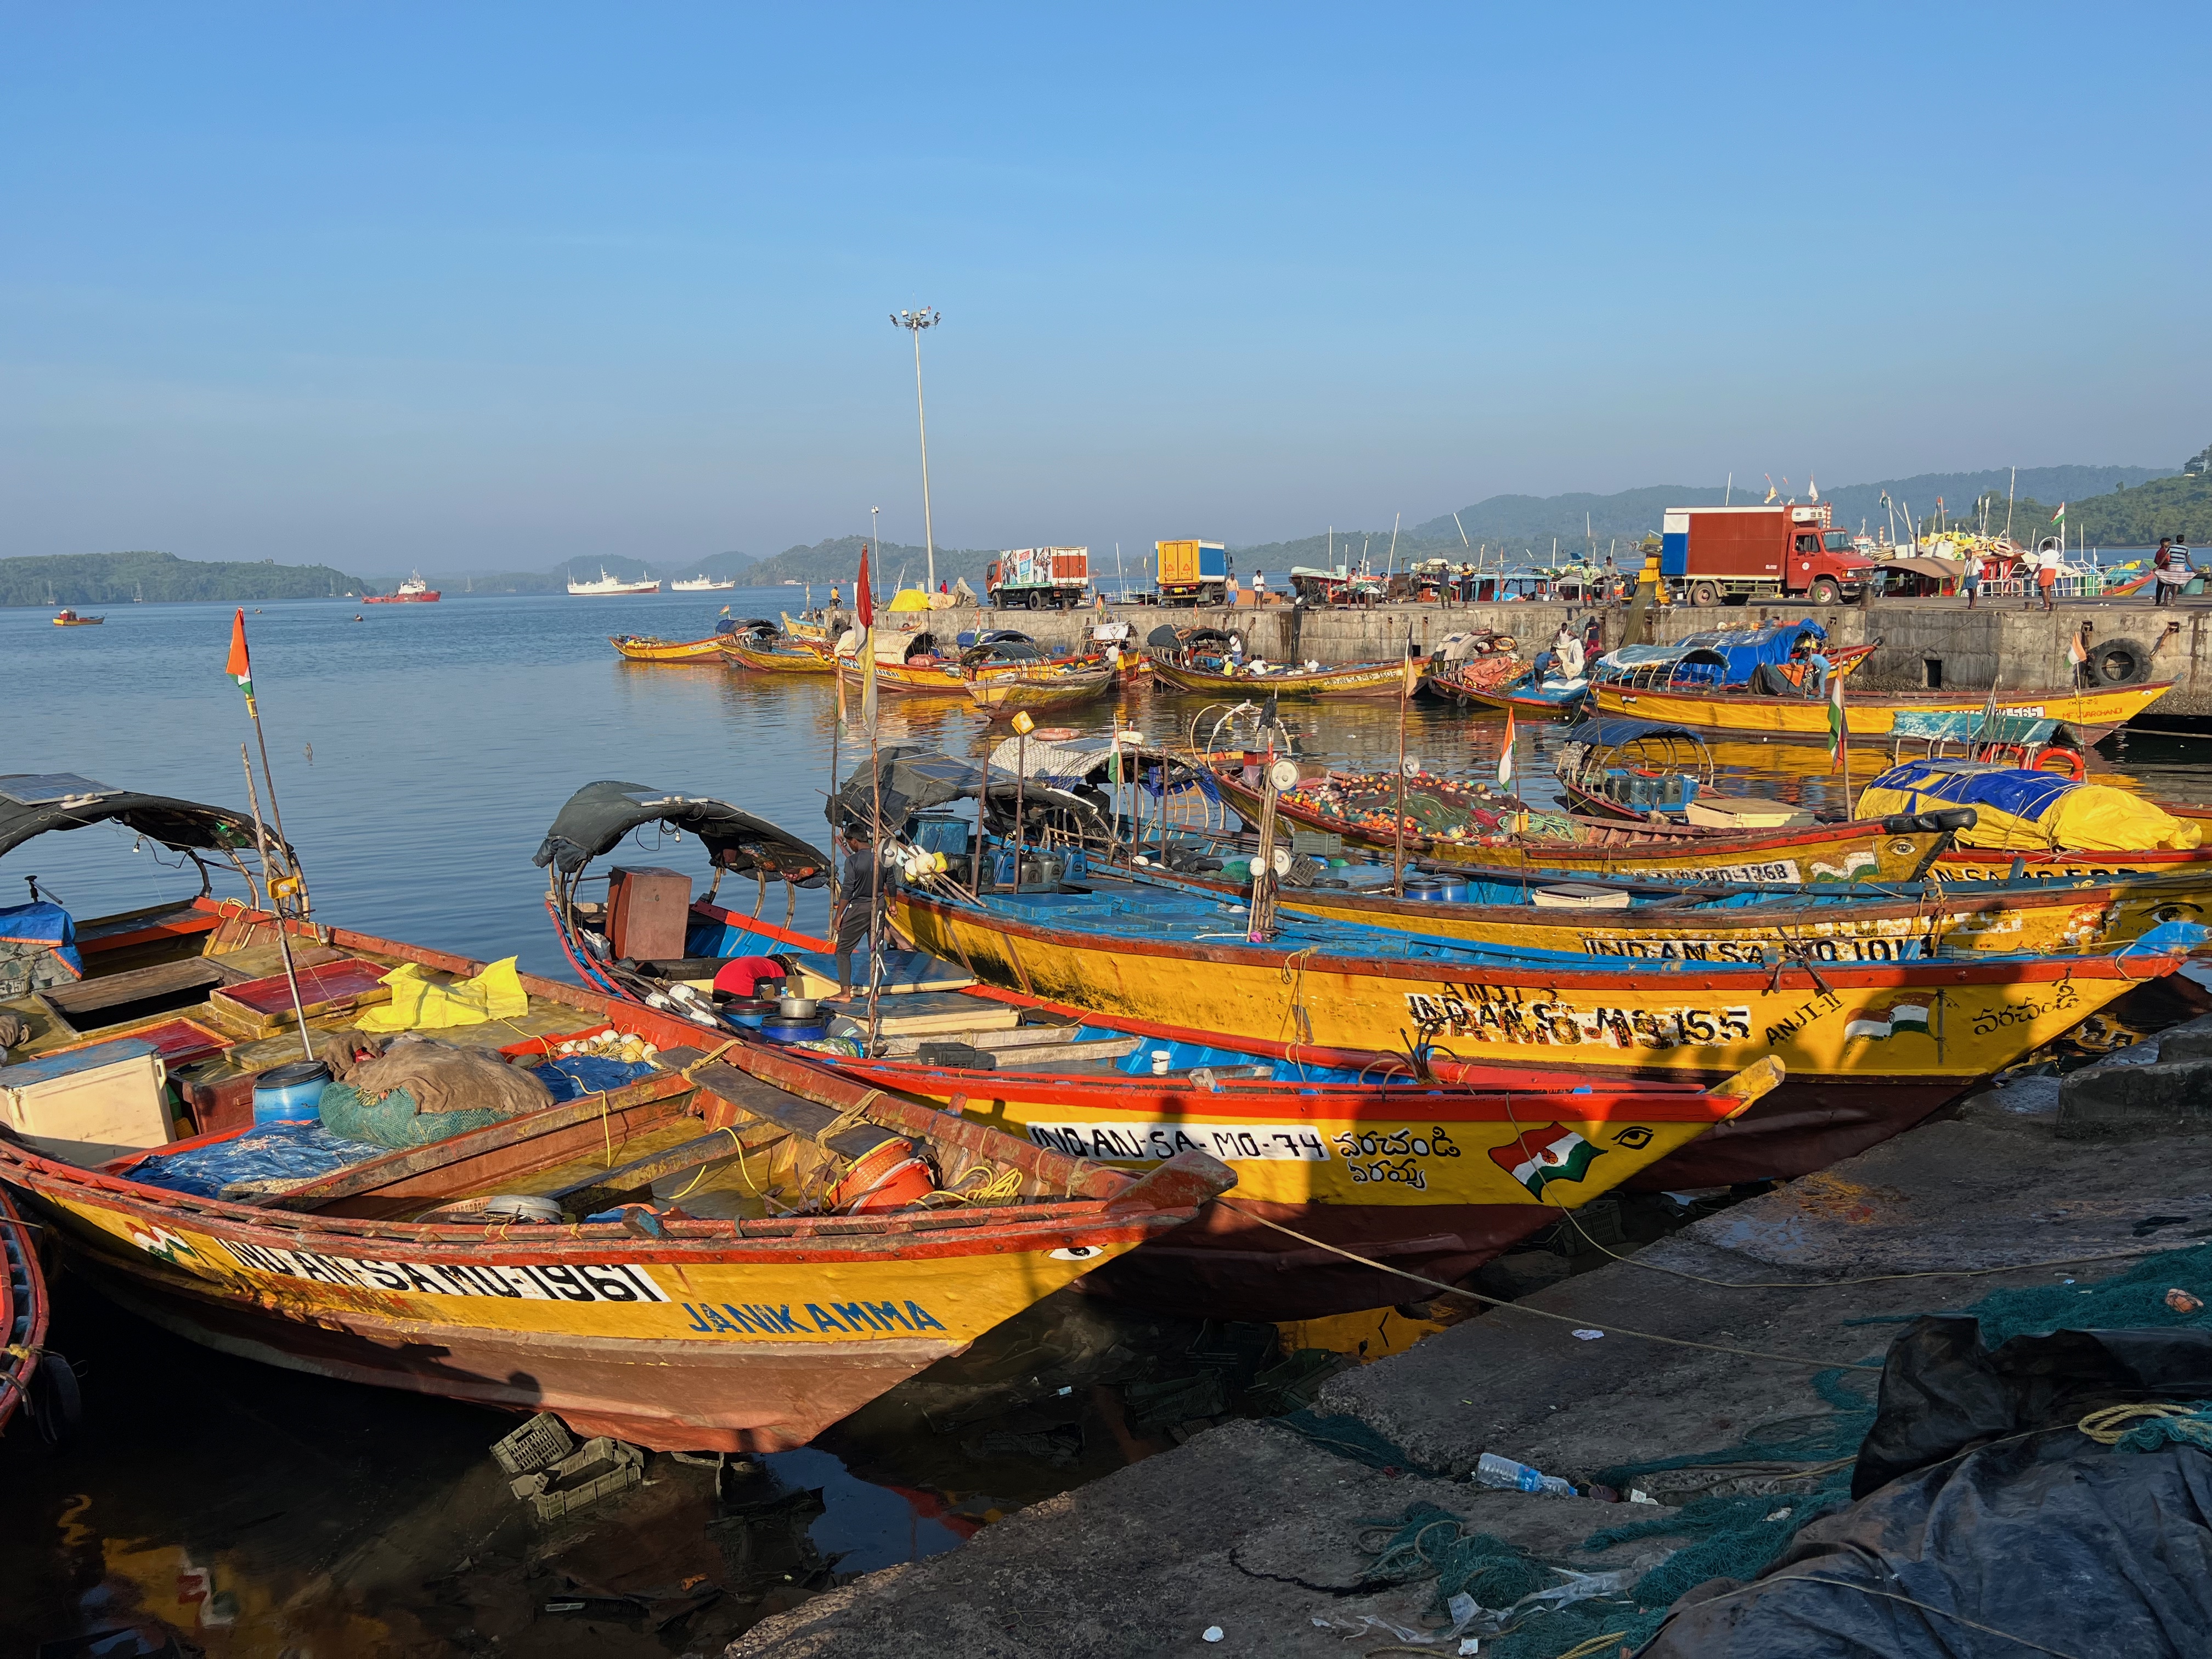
[728,1040,2212,1659]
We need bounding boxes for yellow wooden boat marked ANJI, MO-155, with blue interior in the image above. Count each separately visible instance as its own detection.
[891,889,2181,1186]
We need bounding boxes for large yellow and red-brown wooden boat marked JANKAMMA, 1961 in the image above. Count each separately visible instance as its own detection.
[0,776,1234,1451]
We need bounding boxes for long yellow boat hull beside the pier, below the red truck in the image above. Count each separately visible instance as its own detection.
[1590,679,2174,743]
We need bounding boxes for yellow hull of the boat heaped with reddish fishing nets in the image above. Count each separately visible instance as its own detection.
[1215,761,1966,885]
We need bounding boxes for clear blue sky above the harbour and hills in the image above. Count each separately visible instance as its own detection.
[0,0,2212,571]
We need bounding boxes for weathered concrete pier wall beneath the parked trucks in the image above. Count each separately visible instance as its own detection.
[938,597,2212,716]
